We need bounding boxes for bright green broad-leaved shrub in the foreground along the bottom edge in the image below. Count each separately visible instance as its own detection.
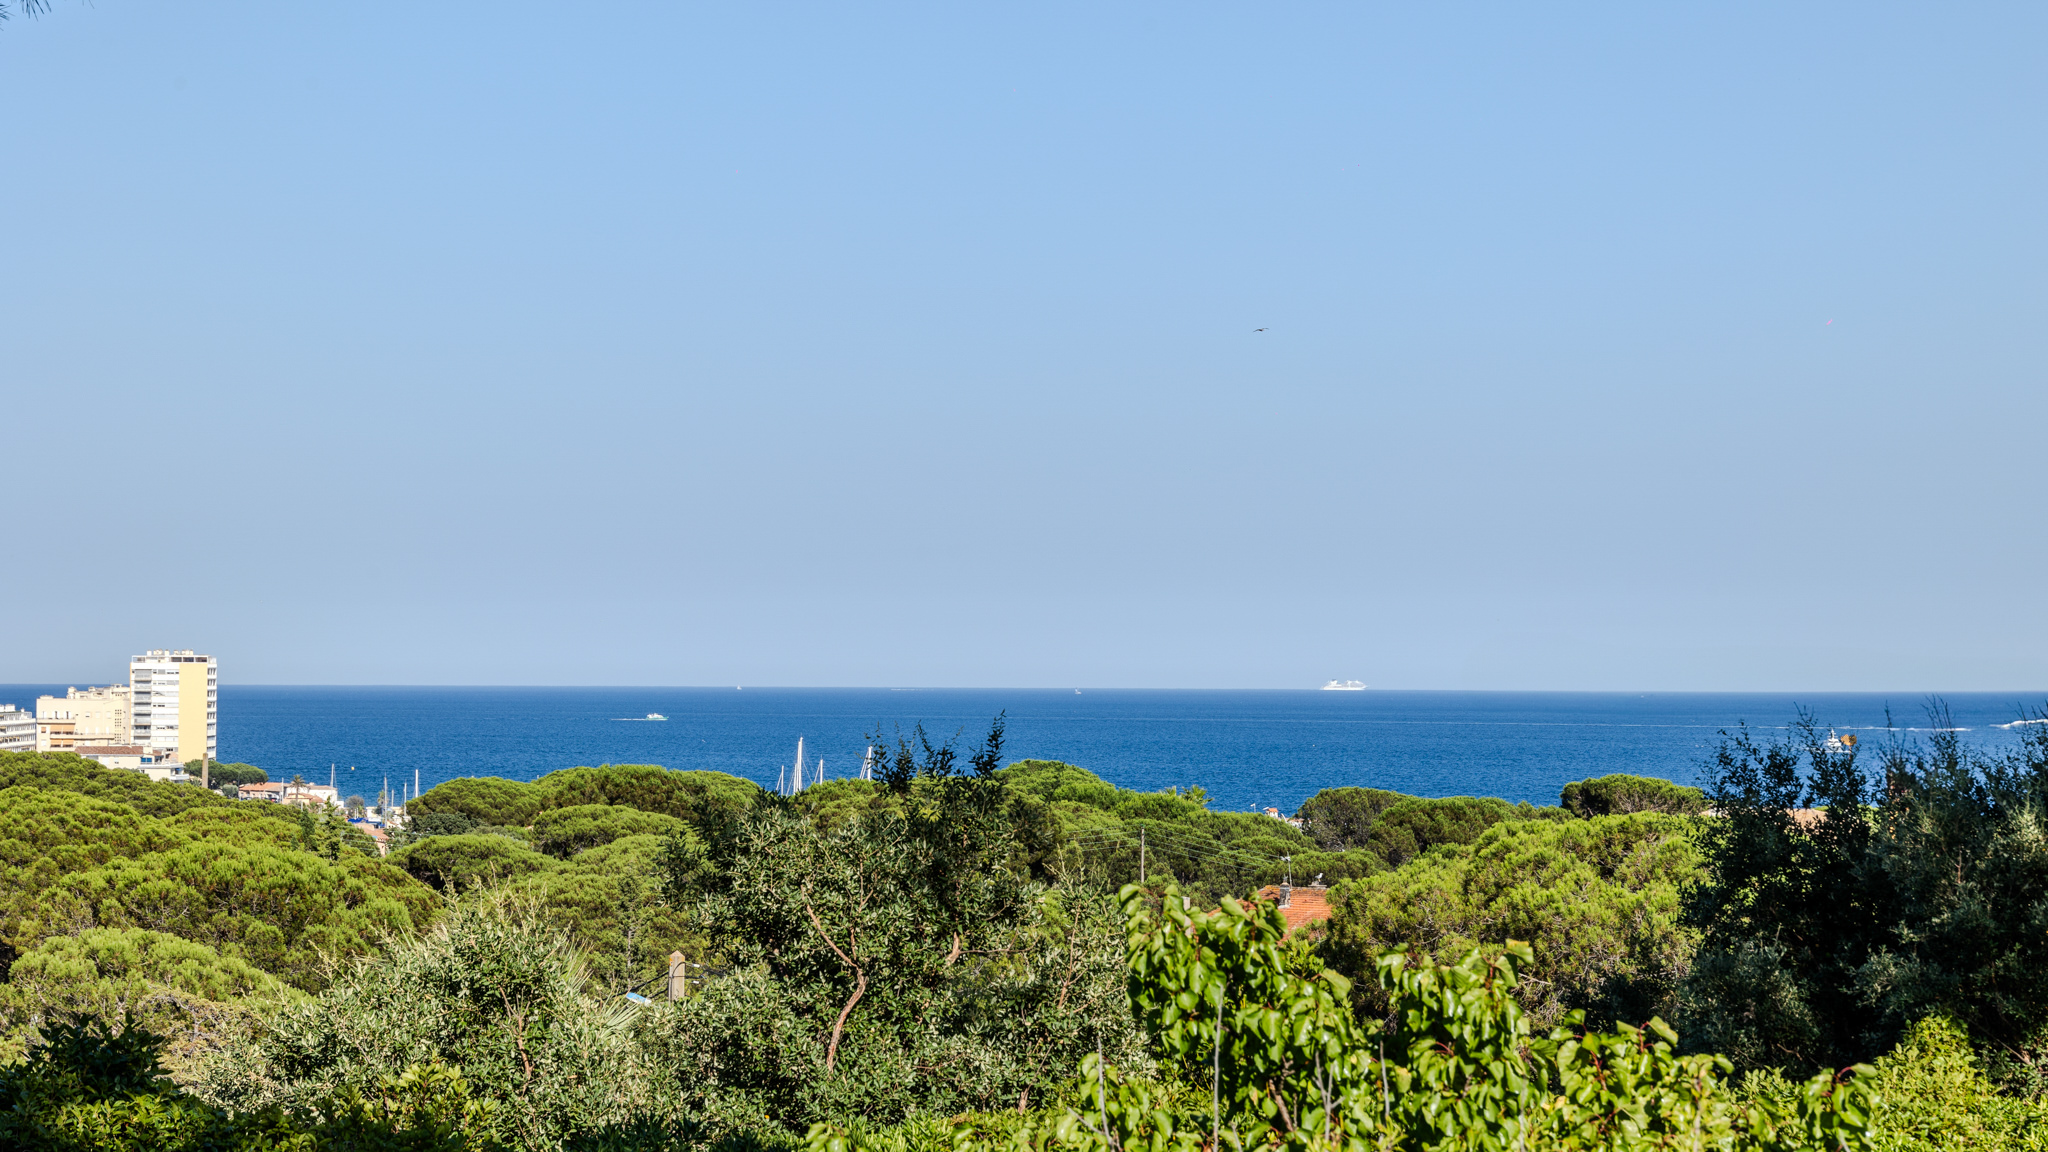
[807,886,1874,1152]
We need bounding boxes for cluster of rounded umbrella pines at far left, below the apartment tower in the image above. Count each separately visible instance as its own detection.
[0,752,438,1066]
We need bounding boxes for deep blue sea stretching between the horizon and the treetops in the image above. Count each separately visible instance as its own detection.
[0,685,2048,812]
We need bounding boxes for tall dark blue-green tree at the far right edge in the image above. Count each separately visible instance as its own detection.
[1683,707,2048,1091]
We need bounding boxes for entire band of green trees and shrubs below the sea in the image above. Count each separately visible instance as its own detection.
[12,719,2048,1152]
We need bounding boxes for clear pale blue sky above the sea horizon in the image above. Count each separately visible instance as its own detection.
[0,0,2048,691]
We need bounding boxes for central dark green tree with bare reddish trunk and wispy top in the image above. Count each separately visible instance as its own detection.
[666,726,1137,1132]
